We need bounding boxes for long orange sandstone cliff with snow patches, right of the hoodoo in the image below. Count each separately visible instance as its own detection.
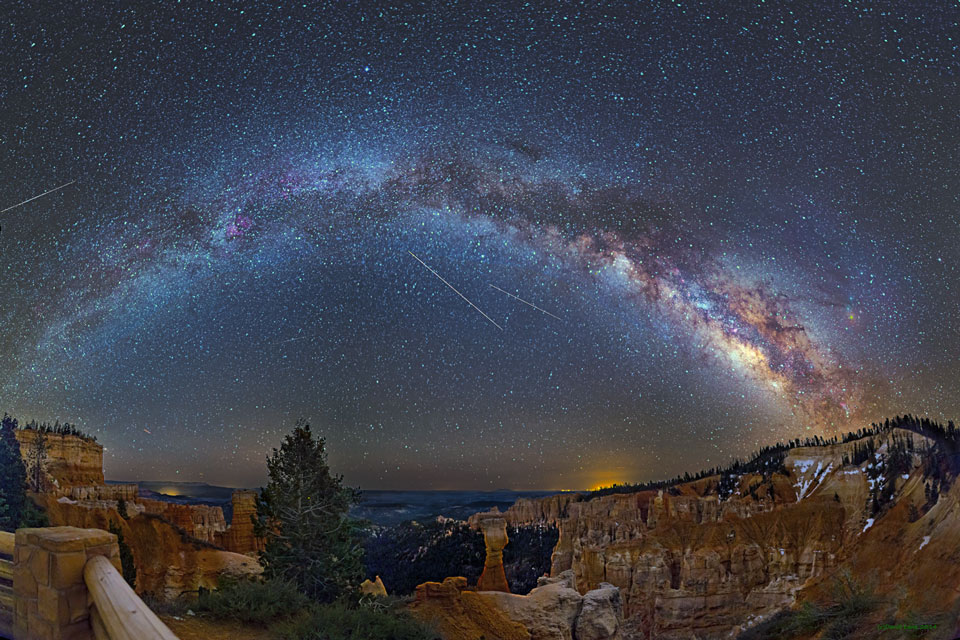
[471,430,948,640]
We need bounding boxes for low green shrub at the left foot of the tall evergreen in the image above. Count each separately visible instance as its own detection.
[197,578,310,626]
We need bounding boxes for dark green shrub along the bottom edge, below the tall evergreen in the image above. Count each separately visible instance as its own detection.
[275,602,440,640]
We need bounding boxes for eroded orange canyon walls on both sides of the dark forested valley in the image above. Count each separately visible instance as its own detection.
[18,428,960,640]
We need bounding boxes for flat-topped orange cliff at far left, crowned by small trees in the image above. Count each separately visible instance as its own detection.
[16,429,104,495]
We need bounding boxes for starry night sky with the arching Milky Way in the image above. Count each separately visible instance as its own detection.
[0,1,960,489]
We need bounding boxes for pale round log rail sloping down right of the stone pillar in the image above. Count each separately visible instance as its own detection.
[83,556,177,640]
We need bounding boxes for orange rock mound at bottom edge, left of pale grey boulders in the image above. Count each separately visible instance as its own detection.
[410,577,531,640]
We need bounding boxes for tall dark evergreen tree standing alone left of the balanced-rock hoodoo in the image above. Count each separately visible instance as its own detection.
[255,420,364,602]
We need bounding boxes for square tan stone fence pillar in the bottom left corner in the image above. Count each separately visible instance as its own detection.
[13,527,120,640]
